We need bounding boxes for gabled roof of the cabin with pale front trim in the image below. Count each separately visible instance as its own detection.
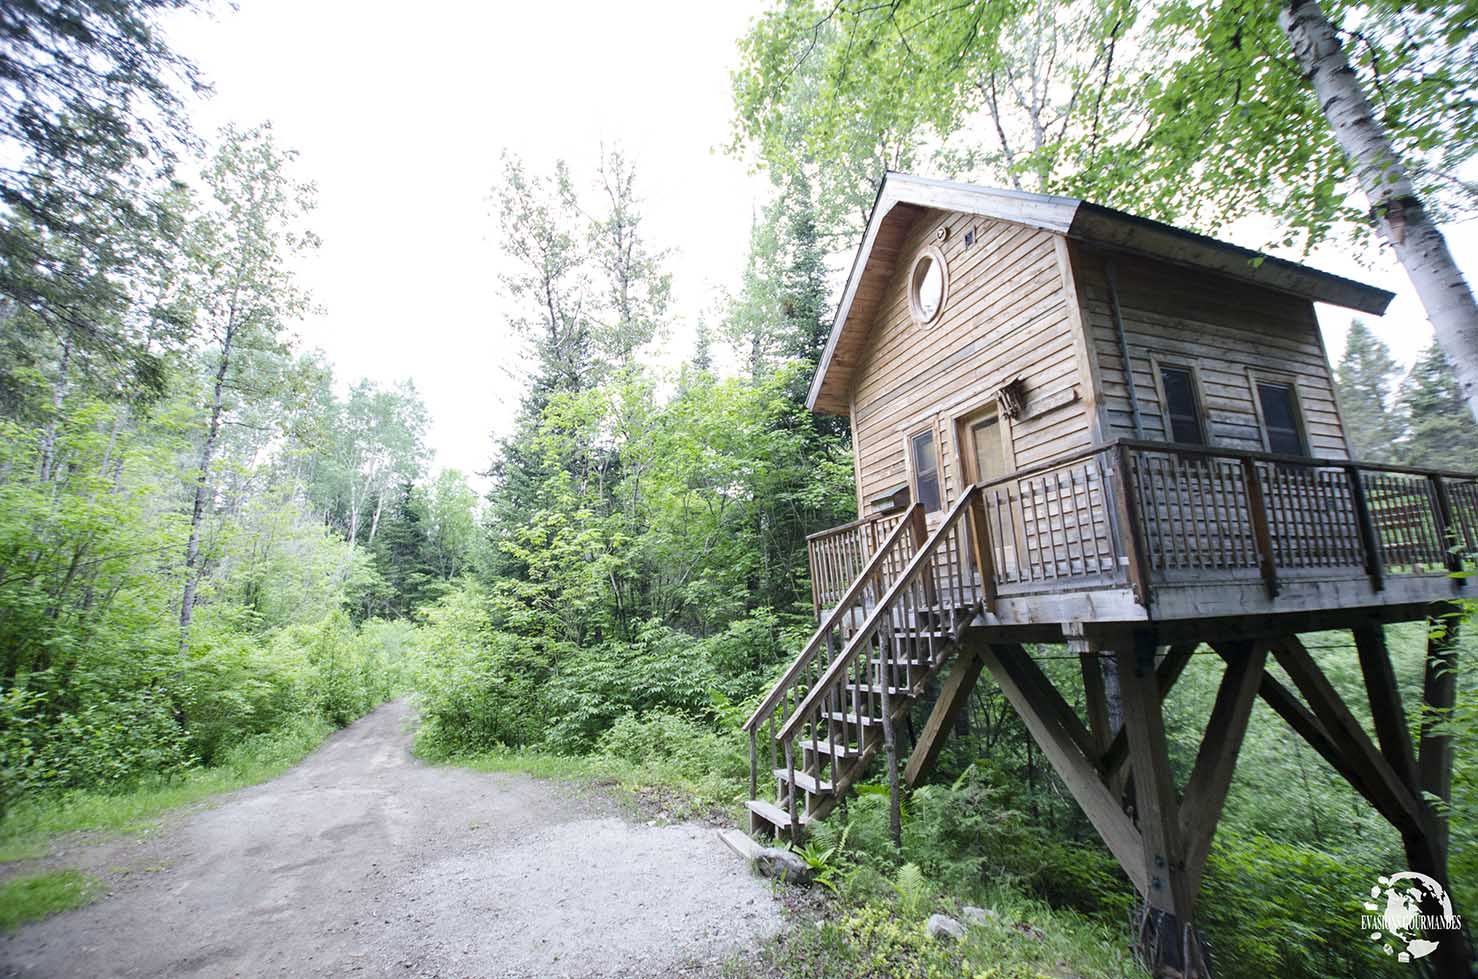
[806,170,1394,414]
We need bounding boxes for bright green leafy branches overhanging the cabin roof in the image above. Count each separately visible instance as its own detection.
[733,0,1478,247]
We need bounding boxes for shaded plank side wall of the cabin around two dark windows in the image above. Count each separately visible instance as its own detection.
[1073,248,1349,458]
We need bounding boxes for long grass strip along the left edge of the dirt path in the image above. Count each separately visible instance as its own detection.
[0,717,334,862]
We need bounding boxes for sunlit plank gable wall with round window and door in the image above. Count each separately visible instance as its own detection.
[851,211,1091,506]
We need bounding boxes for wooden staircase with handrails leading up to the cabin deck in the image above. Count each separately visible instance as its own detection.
[745,499,983,841]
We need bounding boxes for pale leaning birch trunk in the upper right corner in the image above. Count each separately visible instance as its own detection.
[1278,0,1478,419]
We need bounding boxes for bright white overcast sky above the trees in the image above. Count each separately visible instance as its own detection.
[170,0,1478,482]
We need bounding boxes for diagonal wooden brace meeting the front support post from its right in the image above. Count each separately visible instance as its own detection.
[1181,642,1268,902]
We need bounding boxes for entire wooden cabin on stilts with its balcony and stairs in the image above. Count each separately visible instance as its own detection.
[746,173,1478,979]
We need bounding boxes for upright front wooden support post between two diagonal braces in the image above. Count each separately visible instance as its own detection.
[1114,633,1199,976]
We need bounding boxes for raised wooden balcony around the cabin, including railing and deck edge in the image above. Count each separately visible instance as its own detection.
[810,439,1478,627]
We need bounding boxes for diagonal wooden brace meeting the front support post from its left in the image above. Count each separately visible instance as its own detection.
[981,643,1148,893]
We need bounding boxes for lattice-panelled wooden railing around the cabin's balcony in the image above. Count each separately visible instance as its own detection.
[811,439,1478,609]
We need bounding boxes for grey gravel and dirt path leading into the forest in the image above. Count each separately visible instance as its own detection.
[0,704,780,976]
